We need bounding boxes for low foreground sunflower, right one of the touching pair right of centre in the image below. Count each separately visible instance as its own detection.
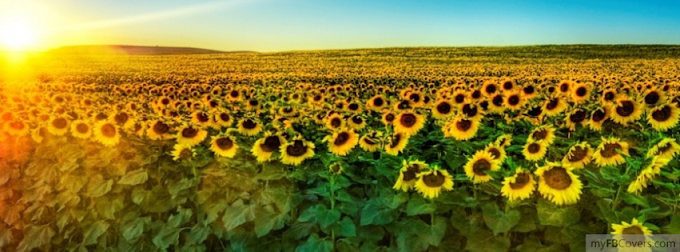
[415,164,453,199]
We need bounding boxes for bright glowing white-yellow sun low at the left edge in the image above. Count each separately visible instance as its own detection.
[0,20,38,51]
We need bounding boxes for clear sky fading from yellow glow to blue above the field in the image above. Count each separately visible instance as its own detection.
[0,0,680,52]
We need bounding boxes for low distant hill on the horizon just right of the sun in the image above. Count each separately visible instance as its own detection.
[48,45,244,55]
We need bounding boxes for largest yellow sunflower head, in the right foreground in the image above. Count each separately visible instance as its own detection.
[536,162,583,205]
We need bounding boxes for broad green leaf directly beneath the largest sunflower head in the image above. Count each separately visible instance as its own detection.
[536,199,581,227]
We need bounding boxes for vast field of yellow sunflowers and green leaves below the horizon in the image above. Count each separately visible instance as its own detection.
[0,46,680,251]
